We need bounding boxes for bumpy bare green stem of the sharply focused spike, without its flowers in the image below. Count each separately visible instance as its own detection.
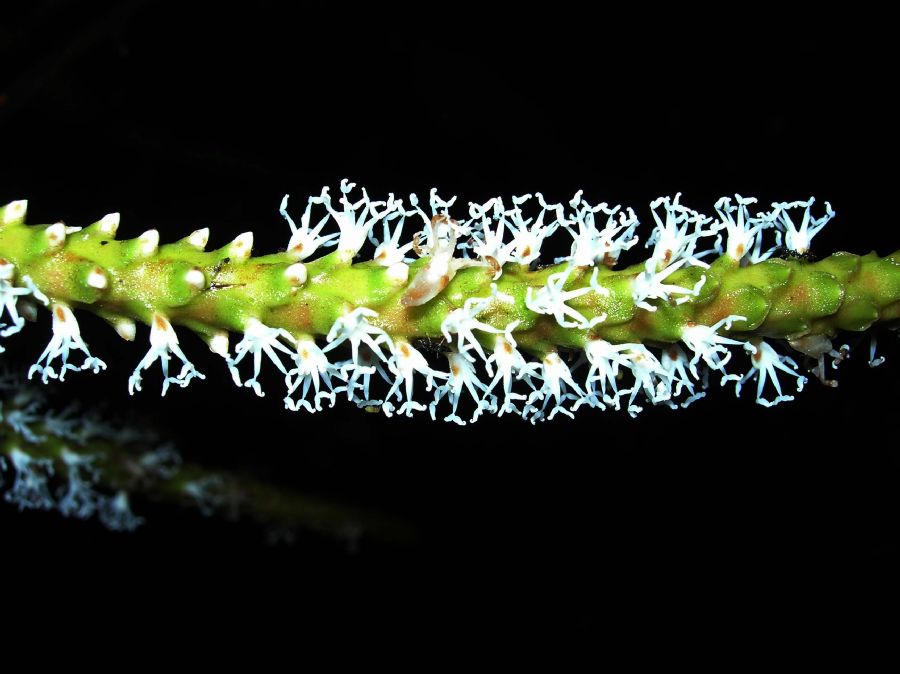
[0,213,900,355]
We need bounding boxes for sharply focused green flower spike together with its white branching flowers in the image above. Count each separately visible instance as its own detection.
[0,186,900,423]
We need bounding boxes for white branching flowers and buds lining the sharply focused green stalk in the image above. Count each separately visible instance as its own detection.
[0,180,880,422]
